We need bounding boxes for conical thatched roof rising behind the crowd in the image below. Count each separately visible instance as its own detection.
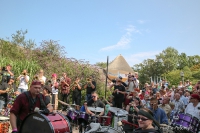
[108,54,134,74]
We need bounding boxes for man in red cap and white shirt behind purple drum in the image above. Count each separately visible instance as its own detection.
[185,94,200,120]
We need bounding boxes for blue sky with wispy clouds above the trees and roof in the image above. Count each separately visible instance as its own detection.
[0,0,200,66]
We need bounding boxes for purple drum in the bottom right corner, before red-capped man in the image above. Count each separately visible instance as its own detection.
[171,113,200,133]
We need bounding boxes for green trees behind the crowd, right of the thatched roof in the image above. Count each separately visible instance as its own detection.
[133,47,200,86]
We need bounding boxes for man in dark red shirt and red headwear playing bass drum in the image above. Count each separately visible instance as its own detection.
[10,80,53,133]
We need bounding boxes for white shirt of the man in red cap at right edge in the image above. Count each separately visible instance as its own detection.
[185,103,200,120]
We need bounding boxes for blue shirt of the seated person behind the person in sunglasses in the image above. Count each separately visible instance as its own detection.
[150,107,168,124]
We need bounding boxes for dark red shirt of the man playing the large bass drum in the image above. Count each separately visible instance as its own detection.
[10,92,44,120]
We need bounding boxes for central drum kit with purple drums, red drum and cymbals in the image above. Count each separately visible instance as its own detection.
[57,104,131,133]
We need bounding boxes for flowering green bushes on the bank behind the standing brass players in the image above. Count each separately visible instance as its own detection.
[0,30,109,105]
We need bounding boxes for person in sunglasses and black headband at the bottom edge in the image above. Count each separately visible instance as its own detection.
[134,108,162,133]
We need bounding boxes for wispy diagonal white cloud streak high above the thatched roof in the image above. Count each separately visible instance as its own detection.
[100,25,141,51]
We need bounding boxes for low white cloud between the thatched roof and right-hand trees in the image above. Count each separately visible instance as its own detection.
[124,51,162,67]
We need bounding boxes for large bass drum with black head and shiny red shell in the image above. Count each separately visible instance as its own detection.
[19,113,72,133]
